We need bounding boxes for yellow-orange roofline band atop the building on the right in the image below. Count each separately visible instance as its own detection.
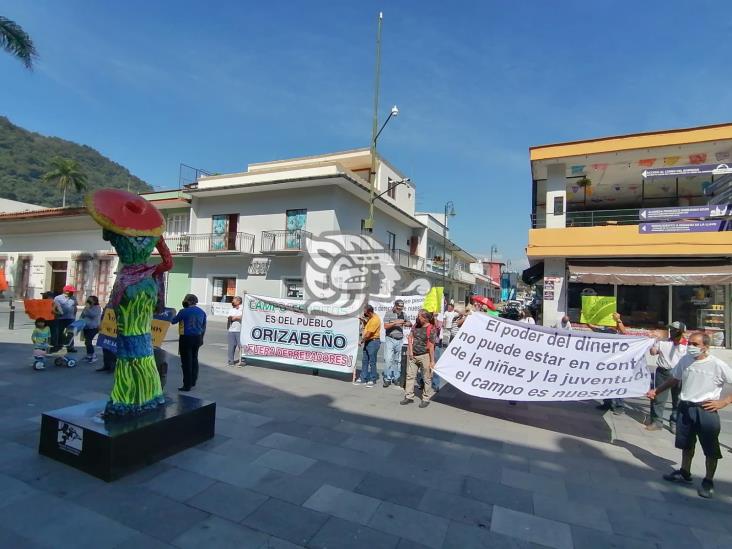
[529,122,732,162]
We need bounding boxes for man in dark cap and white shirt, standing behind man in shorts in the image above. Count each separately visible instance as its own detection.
[646,320,686,433]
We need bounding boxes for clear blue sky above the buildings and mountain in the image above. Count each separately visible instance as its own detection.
[0,0,732,265]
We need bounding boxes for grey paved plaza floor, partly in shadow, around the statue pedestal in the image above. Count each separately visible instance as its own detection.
[0,316,732,549]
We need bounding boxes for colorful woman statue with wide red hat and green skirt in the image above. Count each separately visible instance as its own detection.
[86,189,173,417]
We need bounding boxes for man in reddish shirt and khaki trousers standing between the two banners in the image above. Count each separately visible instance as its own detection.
[399,309,437,408]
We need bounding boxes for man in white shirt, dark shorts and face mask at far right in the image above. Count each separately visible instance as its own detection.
[646,333,732,498]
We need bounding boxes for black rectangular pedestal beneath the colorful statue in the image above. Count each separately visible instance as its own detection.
[38,395,216,482]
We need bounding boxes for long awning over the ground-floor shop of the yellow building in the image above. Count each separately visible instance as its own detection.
[568,263,732,286]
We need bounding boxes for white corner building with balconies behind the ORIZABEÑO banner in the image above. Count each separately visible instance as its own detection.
[181,149,475,304]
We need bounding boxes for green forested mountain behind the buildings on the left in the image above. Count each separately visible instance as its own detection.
[0,116,152,207]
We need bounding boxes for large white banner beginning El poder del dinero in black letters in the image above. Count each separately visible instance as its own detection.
[435,313,654,401]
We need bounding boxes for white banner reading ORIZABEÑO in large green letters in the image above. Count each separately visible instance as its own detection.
[241,294,359,373]
